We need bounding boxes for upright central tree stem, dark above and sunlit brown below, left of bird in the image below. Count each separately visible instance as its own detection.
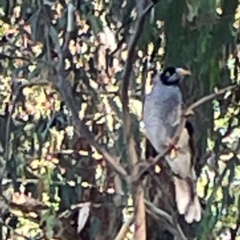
[121,0,157,240]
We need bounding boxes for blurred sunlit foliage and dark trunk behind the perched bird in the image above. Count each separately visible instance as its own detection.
[0,0,240,240]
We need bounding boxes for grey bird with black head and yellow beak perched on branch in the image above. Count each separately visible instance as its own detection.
[143,67,201,223]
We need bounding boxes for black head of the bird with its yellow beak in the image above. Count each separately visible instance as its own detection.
[160,67,190,86]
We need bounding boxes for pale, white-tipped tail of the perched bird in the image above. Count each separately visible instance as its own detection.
[174,177,201,223]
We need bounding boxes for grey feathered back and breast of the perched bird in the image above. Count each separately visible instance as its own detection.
[143,71,182,153]
